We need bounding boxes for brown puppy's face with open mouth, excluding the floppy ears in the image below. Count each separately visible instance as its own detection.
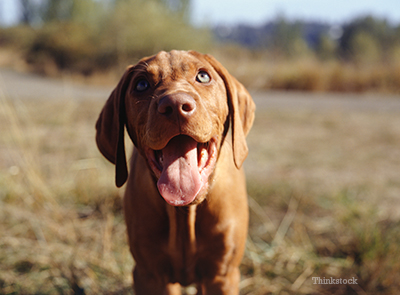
[125,51,229,205]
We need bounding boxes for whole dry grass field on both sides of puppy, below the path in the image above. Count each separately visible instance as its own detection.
[0,82,400,295]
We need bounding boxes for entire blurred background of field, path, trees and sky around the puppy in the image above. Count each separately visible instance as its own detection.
[0,0,400,295]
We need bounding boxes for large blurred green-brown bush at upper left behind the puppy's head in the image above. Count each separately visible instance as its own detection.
[9,0,211,75]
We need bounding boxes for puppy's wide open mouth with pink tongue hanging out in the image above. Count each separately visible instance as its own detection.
[146,135,217,206]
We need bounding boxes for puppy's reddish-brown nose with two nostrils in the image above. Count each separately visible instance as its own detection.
[157,93,196,117]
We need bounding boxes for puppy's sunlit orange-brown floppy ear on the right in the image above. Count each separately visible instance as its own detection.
[204,55,255,169]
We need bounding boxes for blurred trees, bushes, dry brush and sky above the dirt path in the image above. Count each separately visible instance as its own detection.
[0,0,400,92]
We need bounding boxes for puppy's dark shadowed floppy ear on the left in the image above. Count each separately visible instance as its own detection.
[96,66,133,187]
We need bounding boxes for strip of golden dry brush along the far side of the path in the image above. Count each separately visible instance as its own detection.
[0,47,400,94]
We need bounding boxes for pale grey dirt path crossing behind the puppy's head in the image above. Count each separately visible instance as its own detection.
[0,69,400,112]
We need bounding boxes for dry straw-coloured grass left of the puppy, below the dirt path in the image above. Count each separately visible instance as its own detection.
[0,96,133,294]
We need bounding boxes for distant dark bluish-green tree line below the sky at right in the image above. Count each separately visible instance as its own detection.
[214,16,400,63]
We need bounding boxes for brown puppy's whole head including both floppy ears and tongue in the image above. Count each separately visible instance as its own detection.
[96,51,255,206]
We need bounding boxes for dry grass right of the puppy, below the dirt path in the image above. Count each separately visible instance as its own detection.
[243,107,400,294]
